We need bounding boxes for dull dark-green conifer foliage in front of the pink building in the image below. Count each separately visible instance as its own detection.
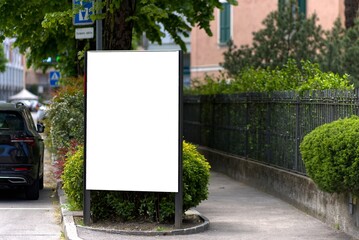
[222,1,359,87]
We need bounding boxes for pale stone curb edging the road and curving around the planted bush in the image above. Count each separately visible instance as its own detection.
[57,181,209,240]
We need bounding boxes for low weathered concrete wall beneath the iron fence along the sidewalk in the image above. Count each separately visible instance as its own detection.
[198,147,359,237]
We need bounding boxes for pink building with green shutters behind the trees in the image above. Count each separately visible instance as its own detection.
[190,0,344,79]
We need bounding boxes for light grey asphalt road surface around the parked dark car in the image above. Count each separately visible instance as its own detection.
[0,145,61,240]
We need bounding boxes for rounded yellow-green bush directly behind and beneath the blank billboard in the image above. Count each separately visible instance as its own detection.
[62,142,210,222]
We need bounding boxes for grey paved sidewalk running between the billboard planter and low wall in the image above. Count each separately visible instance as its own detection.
[77,172,359,240]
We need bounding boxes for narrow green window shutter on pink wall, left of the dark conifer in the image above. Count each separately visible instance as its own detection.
[219,2,231,44]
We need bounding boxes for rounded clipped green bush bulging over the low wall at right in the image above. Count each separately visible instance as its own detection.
[300,116,359,194]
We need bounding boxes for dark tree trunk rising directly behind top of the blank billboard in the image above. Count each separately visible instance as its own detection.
[103,0,136,50]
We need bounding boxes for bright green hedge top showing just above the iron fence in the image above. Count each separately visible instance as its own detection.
[186,59,353,95]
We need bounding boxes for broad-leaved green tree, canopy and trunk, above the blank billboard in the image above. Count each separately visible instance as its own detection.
[0,0,236,75]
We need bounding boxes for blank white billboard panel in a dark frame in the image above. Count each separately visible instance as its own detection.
[86,51,180,192]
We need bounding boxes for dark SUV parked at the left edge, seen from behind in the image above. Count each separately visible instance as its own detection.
[0,103,44,200]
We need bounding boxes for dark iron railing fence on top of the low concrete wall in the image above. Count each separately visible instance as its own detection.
[183,89,359,174]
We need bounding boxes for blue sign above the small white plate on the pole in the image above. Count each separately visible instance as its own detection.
[72,0,93,26]
